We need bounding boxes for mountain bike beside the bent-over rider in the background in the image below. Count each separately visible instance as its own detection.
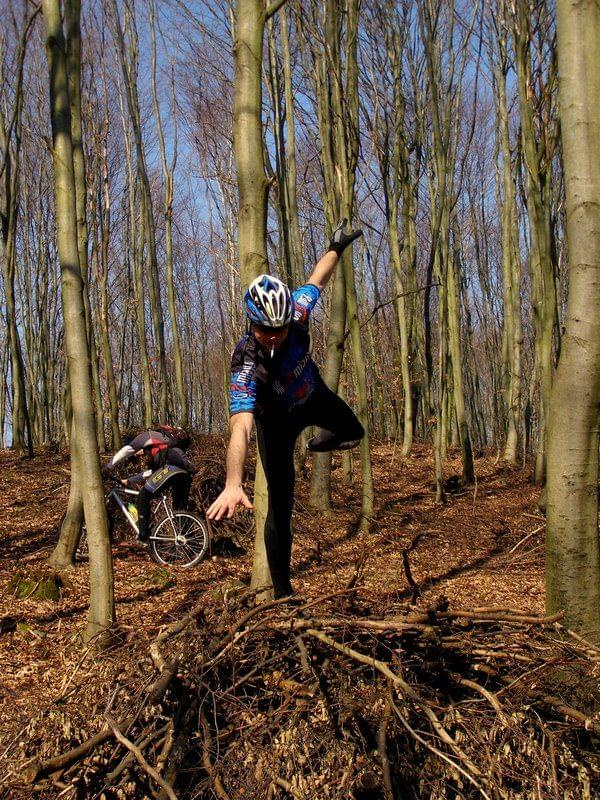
[76,479,209,568]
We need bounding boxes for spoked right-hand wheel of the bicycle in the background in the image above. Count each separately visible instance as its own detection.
[150,511,208,567]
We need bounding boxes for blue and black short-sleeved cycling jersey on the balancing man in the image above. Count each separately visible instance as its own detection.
[230,283,321,415]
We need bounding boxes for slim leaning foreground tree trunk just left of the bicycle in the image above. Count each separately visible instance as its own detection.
[42,0,115,641]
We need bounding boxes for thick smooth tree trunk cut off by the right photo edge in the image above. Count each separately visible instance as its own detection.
[546,0,600,642]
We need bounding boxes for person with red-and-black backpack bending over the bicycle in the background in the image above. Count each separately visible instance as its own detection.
[104,425,196,543]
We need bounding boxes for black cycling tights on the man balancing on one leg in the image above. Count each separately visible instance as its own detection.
[256,384,364,598]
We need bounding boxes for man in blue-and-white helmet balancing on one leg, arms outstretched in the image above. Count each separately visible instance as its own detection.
[207,220,364,598]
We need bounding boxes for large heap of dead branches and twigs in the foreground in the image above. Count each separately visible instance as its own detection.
[10,589,600,800]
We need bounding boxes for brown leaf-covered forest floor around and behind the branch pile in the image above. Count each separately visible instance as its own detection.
[0,437,597,798]
